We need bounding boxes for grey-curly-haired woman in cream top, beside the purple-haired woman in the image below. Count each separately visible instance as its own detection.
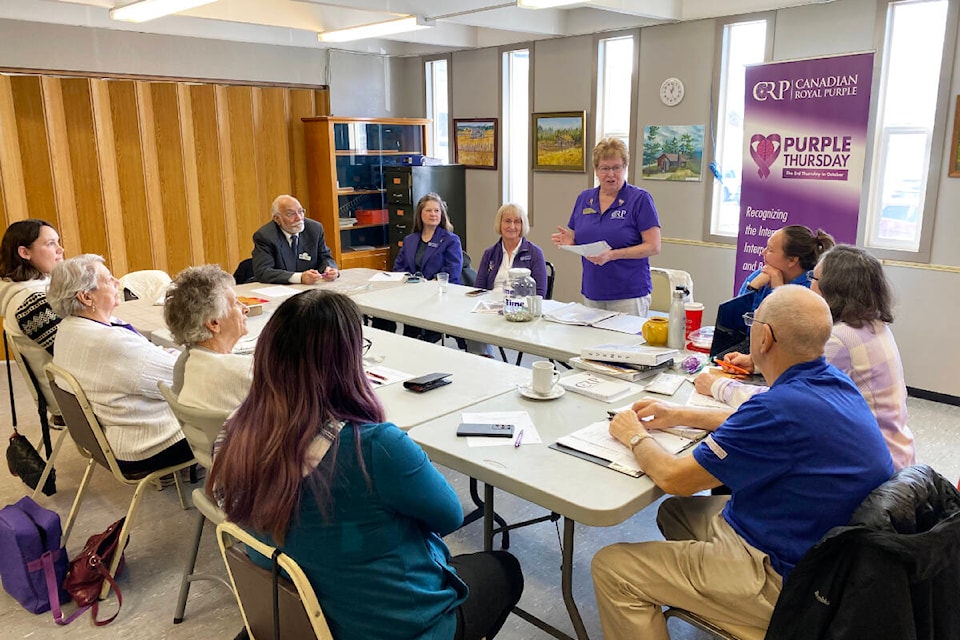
[163,264,253,411]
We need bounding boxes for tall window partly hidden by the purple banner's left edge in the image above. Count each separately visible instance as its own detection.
[710,20,769,237]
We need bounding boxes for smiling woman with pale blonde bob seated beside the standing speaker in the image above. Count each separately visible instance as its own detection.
[477,202,547,296]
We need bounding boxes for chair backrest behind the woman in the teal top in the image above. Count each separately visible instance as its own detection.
[217,521,333,640]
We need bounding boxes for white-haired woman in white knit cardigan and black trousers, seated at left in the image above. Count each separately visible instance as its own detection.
[47,253,193,474]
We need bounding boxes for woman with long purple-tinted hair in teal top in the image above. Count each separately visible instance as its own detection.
[209,290,523,640]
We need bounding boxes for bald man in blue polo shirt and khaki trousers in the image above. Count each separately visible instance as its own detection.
[592,285,893,640]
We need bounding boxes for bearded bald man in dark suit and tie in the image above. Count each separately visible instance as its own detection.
[252,195,340,284]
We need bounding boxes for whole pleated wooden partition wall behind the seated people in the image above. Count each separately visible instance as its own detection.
[0,72,328,276]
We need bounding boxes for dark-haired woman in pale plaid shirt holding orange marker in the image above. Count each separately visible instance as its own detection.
[695,245,916,470]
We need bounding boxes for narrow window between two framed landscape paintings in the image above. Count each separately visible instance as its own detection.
[500,49,530,211]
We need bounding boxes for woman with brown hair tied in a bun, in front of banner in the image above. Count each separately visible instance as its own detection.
[738,224,836,310]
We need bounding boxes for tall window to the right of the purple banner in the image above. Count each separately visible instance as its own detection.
[866,0,948,252]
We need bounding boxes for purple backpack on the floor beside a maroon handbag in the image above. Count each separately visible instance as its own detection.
[0,497,70,613]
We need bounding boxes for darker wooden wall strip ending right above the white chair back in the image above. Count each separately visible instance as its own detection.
[107,80,155,275]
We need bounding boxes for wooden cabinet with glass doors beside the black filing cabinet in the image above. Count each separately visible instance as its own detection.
[303,116,430,269]
